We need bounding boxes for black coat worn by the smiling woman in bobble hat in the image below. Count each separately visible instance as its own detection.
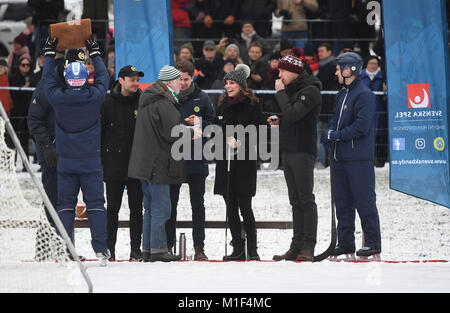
[214,94,263,197]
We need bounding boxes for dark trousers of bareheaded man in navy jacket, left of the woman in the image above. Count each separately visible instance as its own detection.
[166,174,207,247]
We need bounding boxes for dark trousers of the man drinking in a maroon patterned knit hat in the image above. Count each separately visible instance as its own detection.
[283,152,317,252]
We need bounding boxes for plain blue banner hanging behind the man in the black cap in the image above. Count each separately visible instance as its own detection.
[114,0,173,83]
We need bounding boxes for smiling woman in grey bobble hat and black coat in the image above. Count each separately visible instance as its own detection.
[214,64,261,261]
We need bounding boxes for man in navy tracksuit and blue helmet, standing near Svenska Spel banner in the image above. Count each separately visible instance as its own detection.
[321,52,381,257]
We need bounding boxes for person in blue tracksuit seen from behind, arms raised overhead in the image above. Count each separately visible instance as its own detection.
[42,38,109,265]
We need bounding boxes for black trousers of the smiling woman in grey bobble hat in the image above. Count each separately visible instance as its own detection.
[224,188,257,252]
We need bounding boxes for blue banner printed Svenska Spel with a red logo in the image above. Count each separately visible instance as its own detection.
[383,0,450,208]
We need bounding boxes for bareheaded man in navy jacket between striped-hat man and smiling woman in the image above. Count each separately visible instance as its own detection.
[166,61,215,260]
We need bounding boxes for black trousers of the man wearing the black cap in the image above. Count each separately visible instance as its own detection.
[106,178,143,252]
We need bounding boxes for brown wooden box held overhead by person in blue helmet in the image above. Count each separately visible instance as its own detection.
[50,18,92,50]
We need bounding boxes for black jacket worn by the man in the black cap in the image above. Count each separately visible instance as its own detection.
[101,81,141,181]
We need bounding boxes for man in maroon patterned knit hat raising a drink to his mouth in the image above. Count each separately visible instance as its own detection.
[269,51,322,262]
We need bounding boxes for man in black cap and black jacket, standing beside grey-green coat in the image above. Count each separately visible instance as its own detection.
[101,65,144,260]
